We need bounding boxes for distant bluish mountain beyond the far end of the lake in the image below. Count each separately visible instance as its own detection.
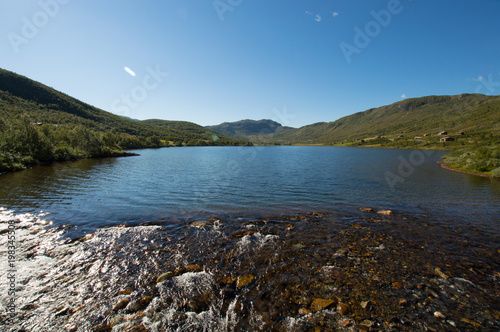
[207,120,293,142]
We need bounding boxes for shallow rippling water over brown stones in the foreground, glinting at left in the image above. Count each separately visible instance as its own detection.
[0,208,500,331]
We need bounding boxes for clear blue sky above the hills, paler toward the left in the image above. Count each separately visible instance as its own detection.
[0,0,500,127]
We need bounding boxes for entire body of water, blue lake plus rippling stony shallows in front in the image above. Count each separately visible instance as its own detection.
[0,146,500,332]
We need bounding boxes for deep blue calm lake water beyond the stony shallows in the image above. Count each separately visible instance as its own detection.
[0,146,500,234]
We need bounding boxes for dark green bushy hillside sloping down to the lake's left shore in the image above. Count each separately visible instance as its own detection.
[0,69,248,172]
